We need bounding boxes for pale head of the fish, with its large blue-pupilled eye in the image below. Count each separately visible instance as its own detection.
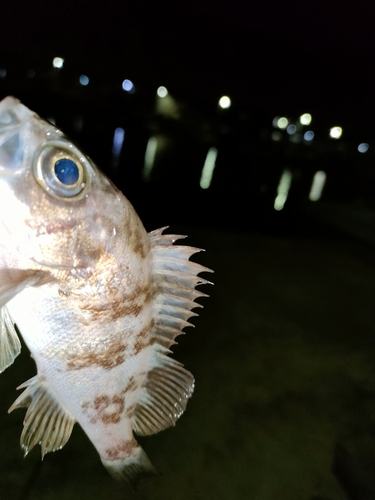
[0,97,125,269]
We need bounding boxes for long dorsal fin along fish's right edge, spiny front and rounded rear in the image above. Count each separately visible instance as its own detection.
[133,228,212,435]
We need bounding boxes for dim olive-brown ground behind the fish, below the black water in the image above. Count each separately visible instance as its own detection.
[0,228,375,500]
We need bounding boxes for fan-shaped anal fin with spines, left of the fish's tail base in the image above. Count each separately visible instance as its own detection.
[8,376,75,458]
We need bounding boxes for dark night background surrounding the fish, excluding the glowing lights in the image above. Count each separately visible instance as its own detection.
[0,0,375,500]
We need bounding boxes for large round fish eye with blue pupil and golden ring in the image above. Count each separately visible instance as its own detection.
[33,140,91,200]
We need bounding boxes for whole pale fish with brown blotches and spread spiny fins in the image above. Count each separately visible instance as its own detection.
[0,96,211,483]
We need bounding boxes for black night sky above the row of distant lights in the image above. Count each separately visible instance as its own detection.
[0,0,375,123]
